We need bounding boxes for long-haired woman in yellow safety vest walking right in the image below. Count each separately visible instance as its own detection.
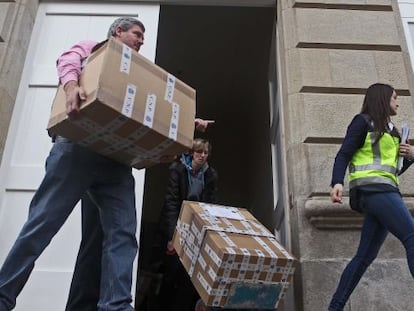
[328,83,414,311]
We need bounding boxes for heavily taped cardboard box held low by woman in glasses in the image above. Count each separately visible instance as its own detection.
[173,201,297,310]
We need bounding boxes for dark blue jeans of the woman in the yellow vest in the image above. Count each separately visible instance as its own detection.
[328,192,414,311]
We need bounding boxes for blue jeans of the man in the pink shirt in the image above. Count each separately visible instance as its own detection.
[0,139,137,311]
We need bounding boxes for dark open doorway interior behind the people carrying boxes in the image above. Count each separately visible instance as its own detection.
[139,5,275,308]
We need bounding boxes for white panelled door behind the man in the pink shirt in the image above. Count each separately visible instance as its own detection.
[0,2,159,311]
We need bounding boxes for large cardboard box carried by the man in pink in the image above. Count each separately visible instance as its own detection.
[48,38,195,168]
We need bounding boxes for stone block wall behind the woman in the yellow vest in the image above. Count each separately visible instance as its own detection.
[277,0,414,311]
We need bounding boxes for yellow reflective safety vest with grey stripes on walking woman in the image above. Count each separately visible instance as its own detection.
[349,132,400,189]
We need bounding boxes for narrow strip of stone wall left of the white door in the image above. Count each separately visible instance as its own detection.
[0,0,39,160]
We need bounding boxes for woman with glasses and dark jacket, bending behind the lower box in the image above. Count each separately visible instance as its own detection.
[161,138,218,311]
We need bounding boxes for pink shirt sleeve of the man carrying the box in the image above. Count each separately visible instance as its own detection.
[56,40,97,85]
